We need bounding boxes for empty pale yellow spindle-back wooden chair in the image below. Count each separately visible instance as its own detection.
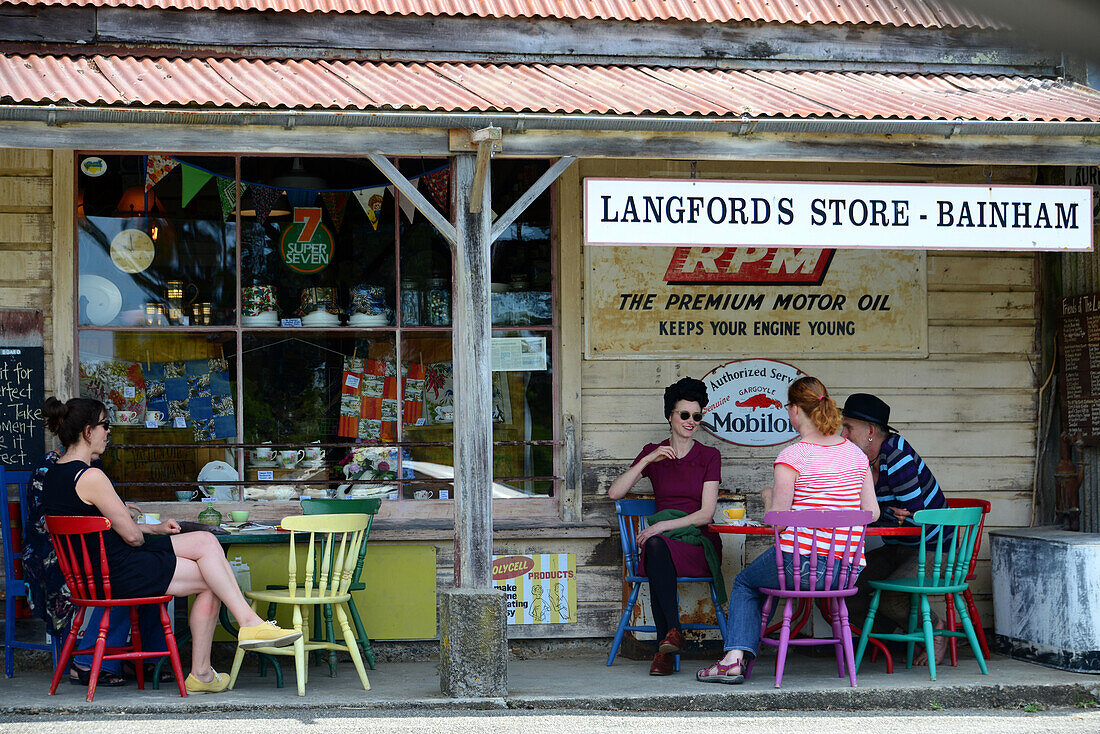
[229,513,371,695]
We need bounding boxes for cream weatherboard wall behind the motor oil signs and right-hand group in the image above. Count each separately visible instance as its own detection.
[559,160,1045,627]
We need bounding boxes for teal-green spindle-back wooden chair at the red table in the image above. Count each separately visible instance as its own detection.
[856,507,989,680]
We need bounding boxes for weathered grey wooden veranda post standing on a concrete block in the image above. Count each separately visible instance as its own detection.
[452,154,493,590]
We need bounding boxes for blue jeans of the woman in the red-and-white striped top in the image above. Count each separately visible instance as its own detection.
[723,547,840,657]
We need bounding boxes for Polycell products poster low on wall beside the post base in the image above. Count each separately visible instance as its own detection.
[493,554,576,625]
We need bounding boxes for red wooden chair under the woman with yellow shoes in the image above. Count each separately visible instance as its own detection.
[46,515,187,701]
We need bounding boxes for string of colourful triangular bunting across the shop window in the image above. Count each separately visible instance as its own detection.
[145,155,451,224]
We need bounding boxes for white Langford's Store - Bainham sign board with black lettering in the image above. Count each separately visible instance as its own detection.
[584,178,1092,252]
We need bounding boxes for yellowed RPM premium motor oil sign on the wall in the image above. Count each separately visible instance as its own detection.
[584,247,928,359]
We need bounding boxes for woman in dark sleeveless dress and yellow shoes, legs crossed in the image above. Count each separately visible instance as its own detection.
[42,397,301,693]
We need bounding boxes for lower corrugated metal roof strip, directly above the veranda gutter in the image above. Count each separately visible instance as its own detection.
[0,55,1100,121]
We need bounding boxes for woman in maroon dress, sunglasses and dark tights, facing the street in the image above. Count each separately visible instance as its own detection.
[607,377,722,676]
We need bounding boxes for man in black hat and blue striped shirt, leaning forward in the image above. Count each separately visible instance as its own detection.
[840,393,947,665]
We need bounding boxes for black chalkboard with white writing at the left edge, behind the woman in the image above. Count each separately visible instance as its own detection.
[0,346,46,471]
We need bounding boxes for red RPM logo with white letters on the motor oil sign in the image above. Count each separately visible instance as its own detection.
[664,248,836,285]
